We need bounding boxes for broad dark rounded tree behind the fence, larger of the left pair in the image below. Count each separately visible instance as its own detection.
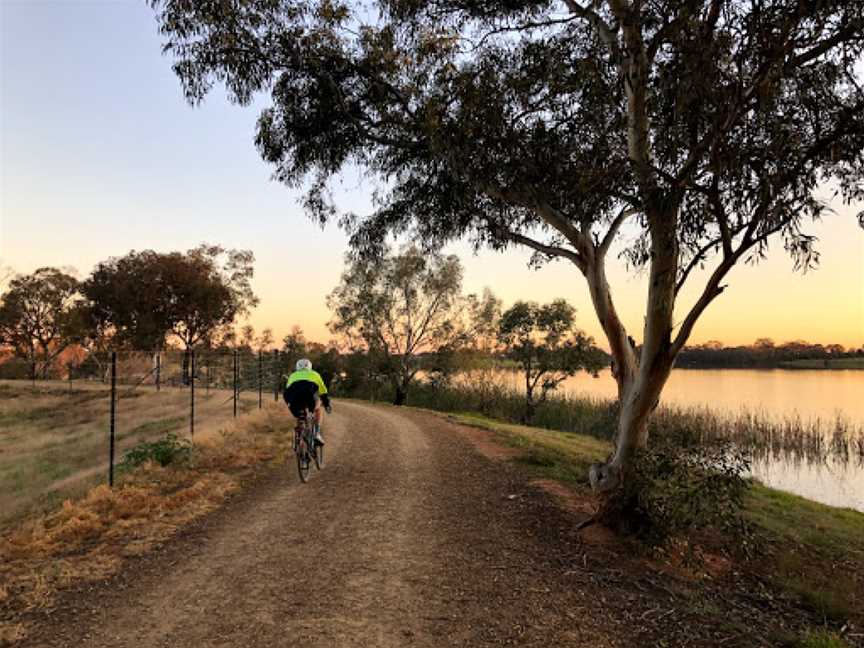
[82,245,257,350]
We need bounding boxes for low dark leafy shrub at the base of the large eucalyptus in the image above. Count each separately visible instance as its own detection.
[602,427,750,548]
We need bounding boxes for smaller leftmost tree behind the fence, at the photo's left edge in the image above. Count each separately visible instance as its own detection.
[0,268,79,378]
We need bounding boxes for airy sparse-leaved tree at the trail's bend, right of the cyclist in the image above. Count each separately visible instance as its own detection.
[327,247,465,405]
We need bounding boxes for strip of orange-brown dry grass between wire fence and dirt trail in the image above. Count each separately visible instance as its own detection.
[0,406,289,643]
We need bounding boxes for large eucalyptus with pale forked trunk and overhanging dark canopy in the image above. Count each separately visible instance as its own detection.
[152,0,864,489]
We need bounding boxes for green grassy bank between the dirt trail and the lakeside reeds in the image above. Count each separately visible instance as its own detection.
[438,413,864,647]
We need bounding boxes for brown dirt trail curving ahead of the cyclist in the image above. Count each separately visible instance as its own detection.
[27,402,613,648]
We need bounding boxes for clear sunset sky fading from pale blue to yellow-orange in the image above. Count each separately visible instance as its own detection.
[0,0,864,347]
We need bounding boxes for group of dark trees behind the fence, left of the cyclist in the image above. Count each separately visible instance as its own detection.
[0,244,260,379]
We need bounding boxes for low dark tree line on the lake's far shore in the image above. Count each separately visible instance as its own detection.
[675,338,864,369]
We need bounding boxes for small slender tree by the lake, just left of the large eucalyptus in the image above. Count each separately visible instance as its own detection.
[498,299,606,422]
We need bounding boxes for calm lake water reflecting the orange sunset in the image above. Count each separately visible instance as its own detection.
[486,369,864,511]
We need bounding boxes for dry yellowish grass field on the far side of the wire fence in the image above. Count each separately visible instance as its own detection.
[0,381,266,526]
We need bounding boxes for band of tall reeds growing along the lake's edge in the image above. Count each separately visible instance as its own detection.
[344,374,864,467]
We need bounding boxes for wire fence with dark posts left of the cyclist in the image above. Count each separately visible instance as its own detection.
[0,349,293,521]
